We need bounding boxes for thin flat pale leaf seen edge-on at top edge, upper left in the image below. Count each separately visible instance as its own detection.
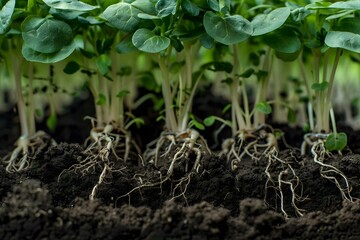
[43,0,99,12]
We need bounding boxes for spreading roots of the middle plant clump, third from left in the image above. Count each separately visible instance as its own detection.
[118,129,211,204]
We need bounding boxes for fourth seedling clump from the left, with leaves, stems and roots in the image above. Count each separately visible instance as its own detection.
[204,1,310,217]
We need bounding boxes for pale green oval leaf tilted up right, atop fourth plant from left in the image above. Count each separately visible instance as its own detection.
[251,7,290,36]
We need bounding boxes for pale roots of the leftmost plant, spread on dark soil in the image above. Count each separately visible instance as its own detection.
[3,131,56,173]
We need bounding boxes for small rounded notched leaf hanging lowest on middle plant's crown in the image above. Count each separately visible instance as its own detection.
[132,28,170,53]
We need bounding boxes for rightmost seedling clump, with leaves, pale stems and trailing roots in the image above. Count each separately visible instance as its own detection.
[292,1,360,204]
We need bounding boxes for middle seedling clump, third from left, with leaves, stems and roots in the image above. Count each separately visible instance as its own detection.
[103,0,215,201]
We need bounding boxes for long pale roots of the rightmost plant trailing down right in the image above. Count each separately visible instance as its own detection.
[301,133,353,202]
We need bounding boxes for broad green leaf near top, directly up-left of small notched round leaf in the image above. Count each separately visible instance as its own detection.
[100,2,142,32]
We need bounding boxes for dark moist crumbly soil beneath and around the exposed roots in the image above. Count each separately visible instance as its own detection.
[0,91,360,240]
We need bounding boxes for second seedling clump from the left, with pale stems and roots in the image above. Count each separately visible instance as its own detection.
[56,0,143,199]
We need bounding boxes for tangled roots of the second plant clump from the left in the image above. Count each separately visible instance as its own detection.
[59,119,140,200]
